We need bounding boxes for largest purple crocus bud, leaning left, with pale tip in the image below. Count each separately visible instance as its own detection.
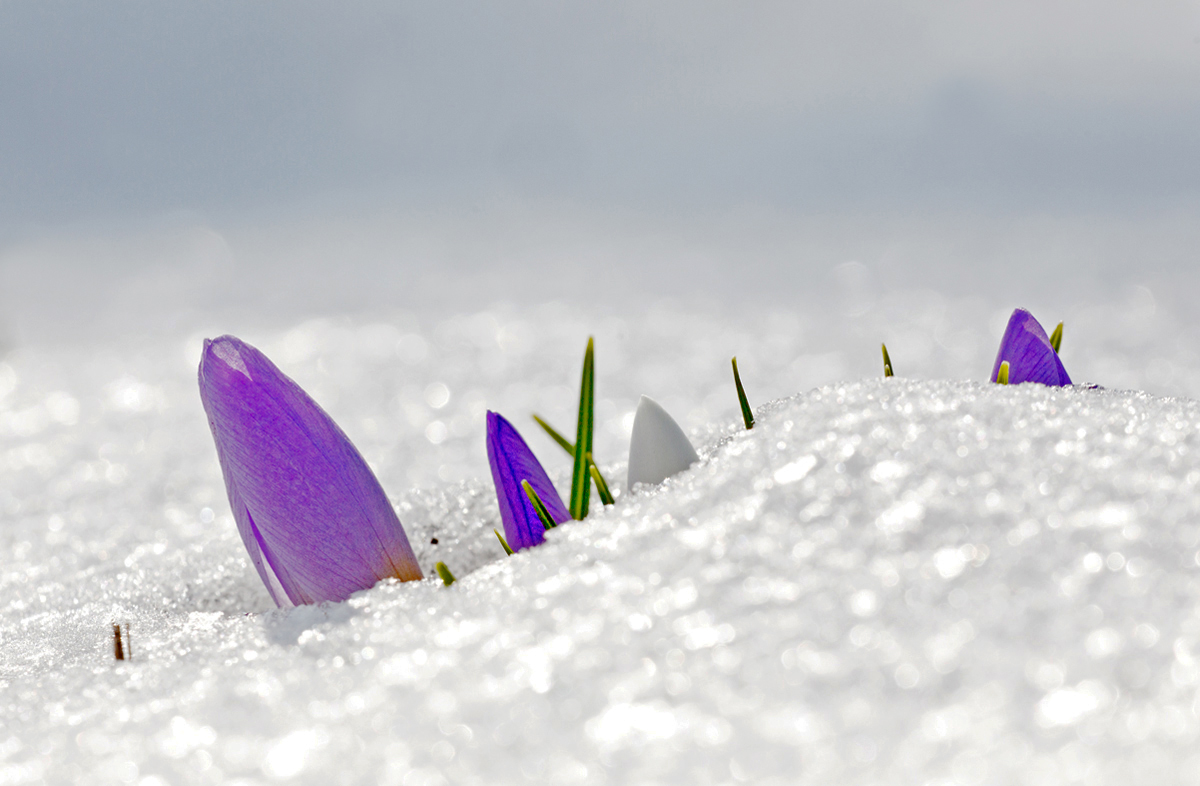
[199,336,422,606]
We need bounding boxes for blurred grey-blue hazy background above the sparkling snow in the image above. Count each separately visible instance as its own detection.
[0,0,1200,346]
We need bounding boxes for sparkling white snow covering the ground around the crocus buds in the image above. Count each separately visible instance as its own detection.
[0,298,1200,786]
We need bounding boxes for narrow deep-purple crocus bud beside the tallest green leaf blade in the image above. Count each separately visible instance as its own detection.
[487,412,571,551]
